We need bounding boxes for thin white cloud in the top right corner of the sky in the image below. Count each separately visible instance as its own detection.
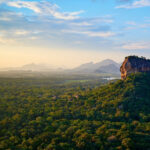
[116,0,150,9]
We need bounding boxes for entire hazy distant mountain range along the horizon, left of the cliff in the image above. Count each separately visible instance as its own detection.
[0,59,120,74]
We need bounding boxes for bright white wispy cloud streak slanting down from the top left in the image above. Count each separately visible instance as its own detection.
[7,1,84,20]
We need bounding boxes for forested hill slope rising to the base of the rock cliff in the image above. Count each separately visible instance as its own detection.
[87,73,150,119]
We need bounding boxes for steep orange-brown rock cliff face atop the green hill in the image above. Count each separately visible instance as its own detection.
[120,56,150,79]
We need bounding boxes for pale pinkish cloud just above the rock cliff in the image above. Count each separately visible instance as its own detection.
[122,42,150,50]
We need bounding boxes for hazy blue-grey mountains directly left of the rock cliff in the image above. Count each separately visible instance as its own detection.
[72,59,121,74]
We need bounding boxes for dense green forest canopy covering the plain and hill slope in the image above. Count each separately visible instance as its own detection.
[0,73,150,150]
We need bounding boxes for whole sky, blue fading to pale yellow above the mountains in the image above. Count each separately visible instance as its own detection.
[0,0,150,68]
